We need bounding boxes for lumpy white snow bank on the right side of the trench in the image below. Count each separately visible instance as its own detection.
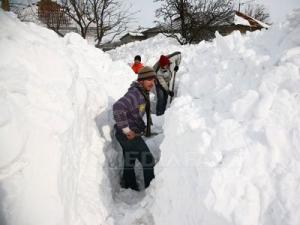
[149,7,300,225]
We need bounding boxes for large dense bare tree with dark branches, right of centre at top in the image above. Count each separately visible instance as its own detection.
[155,0,234,44]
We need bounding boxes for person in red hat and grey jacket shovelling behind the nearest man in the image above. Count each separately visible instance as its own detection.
[153,52,181,116]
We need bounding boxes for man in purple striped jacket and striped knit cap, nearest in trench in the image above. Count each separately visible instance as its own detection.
[113,66,156,191]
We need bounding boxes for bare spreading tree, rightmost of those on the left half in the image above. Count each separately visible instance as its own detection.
[89,0,134,46]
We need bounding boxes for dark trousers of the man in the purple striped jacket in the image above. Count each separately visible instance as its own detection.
[116,130,155,190]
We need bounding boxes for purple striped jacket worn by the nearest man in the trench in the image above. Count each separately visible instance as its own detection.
[113,81,146,133]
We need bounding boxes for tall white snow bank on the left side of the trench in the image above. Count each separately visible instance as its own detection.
[0,11,132,225]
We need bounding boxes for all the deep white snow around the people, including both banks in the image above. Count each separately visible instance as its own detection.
[0,7,300,225]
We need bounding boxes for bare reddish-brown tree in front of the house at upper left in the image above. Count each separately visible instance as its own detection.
[38,0,70,36]
